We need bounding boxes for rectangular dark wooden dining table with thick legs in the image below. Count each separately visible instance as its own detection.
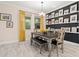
[31,32,57,57]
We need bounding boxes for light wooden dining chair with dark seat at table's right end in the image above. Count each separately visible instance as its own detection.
[52,28,65,56]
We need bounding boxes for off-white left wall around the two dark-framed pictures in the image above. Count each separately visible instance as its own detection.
[0,4,38,44]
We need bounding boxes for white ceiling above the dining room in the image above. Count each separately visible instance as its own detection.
[1,1,75,13]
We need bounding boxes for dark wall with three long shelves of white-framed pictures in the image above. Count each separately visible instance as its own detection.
[46,1,79,43]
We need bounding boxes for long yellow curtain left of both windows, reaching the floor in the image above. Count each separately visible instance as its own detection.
[19,10,25,42]
